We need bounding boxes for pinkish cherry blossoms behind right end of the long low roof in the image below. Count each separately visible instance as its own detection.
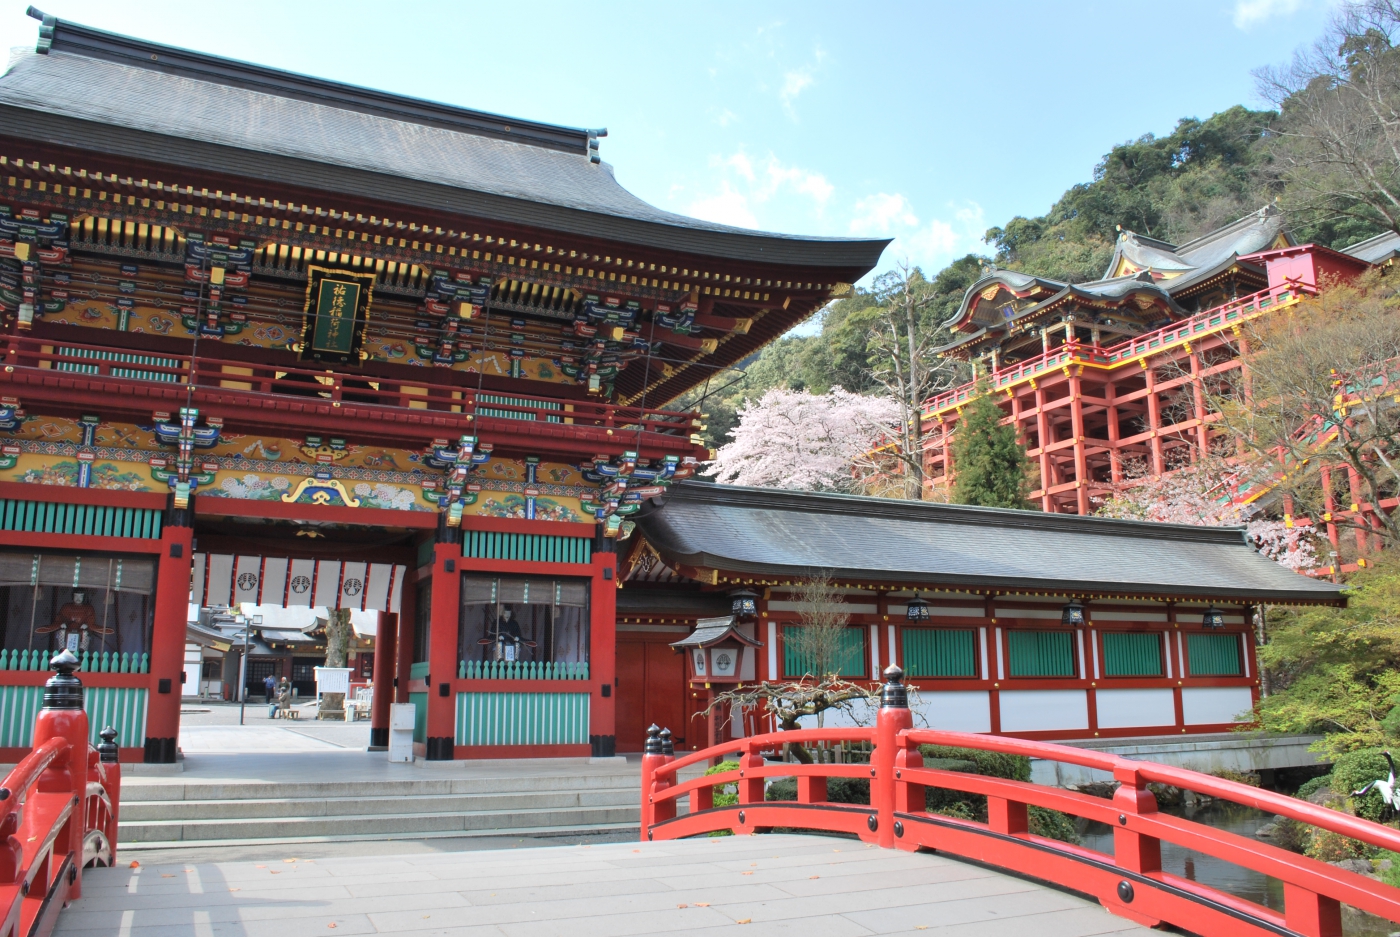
[1098,459,1317,570]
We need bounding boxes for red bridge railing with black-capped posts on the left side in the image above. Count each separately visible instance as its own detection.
[0,651,122,937]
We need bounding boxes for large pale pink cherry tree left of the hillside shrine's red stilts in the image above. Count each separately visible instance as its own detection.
[703,387,900,492]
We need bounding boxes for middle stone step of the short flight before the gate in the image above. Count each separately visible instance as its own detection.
[120,787,638,822]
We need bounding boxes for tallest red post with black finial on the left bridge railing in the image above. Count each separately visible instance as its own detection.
[34,648,88,898]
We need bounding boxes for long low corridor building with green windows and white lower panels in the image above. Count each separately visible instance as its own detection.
[617,480,1345,748]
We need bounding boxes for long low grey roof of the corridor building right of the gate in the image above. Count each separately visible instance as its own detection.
[636,482,1344,605]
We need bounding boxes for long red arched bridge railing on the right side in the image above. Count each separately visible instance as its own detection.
[641,667,1400,937]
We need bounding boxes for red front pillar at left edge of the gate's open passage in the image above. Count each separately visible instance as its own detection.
[145,511,193,765]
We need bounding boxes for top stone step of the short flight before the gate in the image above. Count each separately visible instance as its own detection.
[122,770,641,804]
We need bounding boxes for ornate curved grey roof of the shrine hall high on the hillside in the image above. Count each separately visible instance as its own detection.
[938,206,1292,367]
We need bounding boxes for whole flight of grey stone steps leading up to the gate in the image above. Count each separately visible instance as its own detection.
[118,763,641,847]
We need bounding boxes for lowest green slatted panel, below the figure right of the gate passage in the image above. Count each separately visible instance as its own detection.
[456,693,589,745]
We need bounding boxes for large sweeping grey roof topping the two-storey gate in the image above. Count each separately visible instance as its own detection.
[0,24,888,272]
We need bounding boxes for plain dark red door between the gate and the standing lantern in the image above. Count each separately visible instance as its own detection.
[617,639,703,752]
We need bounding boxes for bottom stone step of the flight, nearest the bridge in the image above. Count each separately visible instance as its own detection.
[118,804,641,843]
